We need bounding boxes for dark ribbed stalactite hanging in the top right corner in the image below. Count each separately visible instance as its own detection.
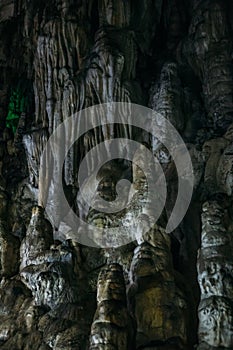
[180,0,233,131]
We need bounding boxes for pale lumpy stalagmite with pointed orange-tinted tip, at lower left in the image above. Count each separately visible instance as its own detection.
[20,207,77,308]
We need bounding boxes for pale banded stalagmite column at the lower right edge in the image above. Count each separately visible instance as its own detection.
[198,201,233,349]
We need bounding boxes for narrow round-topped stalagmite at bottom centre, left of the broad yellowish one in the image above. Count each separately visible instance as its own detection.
[89,264,133,350]
